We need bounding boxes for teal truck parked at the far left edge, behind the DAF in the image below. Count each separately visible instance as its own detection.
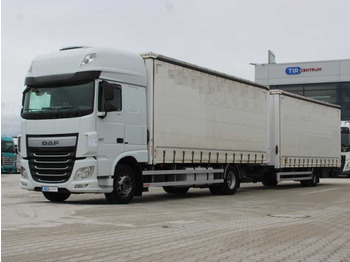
[1,135,16,173]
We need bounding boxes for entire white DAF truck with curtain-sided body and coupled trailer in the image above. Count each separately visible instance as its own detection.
[19,47,340,203]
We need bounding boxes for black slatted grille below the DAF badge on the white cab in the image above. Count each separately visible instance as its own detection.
[28,134,76,183]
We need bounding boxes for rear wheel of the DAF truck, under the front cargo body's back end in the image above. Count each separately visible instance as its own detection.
[209,165,239,195]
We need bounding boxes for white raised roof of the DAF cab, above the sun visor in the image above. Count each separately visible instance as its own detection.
[27,47,147,86]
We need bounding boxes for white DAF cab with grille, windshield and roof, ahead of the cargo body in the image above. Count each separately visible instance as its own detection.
[19,47,148,200]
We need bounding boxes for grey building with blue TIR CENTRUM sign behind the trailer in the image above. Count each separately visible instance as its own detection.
[255,55,350,120]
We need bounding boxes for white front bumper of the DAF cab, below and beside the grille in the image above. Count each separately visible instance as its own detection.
[20,157,113,193]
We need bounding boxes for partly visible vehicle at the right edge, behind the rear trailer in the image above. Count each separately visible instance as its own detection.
[337,121,350,177]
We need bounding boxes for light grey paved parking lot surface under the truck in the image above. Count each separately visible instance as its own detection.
[1,175,350,261]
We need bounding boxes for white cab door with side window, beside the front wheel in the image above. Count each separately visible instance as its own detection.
[96,81,125,176]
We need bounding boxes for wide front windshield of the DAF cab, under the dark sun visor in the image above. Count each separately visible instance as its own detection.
[22,81,94,119]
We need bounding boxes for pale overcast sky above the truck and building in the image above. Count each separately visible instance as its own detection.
[1,0,350,136]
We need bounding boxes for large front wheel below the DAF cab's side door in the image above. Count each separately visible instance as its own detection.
[105,165,136,204]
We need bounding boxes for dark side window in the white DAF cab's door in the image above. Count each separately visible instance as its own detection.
[98,82,122,112]
